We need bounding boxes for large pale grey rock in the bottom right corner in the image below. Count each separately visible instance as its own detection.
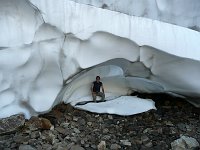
[171,136,199,150]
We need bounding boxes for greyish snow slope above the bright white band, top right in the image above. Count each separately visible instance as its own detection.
[72,0,200,31]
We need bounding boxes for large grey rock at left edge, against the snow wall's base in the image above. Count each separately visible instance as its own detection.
[0,114,25,135]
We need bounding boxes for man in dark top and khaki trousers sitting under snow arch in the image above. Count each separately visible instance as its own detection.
[91,76,105,102]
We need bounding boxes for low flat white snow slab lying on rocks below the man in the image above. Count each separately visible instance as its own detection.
[75,96,156,116]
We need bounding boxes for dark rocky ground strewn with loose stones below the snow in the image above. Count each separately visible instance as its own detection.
[0,94,200,150]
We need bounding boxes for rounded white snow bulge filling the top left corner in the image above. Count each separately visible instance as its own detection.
[0,0,43,47]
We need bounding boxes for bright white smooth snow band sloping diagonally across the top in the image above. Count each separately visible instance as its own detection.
[31,0,200,60]
